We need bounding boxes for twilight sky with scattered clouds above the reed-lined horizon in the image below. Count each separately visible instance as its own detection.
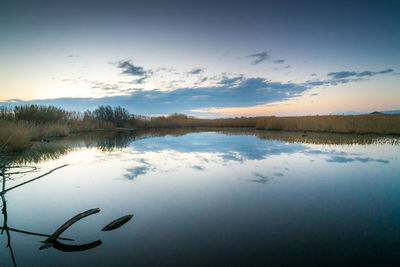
[0,0,400,117]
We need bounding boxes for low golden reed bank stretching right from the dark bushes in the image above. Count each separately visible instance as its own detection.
[140,114,400,134]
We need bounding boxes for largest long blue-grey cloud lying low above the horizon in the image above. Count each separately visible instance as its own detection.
[8,76,309,115]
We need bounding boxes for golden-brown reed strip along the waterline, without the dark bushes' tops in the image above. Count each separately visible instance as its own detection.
[0,114,400,153]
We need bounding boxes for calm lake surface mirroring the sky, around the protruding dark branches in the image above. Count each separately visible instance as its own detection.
[0,130,400,266]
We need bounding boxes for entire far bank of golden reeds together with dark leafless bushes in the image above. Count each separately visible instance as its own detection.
[0,105,400,152]
